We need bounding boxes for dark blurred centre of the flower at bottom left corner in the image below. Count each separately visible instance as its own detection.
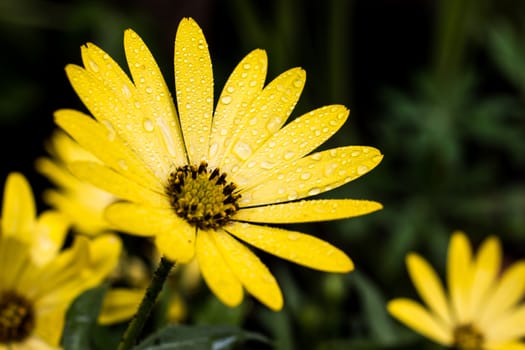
[0,292,35,344]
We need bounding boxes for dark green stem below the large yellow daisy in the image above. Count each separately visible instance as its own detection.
[117,257,175,350]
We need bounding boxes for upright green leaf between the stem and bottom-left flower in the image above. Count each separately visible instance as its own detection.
[62,285,108,350]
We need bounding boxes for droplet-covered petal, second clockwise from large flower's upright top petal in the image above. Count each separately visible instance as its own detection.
[220,68,306,173]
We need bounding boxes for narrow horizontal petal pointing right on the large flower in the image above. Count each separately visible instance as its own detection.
[235,199,383,224]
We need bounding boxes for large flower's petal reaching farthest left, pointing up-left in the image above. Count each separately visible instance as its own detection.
[55,110,162,191]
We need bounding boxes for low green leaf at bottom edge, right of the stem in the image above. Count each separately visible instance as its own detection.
[134,325,270,350]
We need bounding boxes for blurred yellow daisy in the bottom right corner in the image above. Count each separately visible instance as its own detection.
[388,231,525,350]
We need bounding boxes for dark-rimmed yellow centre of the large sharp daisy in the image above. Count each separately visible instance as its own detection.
[166,162,241,230]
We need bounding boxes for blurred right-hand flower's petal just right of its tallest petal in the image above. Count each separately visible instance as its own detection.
[469,237,501,318]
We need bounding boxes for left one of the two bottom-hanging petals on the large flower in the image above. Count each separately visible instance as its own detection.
[196,231,243,307]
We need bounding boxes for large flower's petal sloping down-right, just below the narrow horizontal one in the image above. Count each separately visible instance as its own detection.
[225,223,354,272]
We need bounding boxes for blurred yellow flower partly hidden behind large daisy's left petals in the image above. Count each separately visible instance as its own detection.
[35,129,117,236]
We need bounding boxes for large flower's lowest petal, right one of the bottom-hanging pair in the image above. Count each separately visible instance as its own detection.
[209,231,283,311]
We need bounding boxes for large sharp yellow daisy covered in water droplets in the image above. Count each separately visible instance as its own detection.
[55,18,382,310]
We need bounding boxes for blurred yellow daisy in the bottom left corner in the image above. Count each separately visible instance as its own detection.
[0,173,121,350]
